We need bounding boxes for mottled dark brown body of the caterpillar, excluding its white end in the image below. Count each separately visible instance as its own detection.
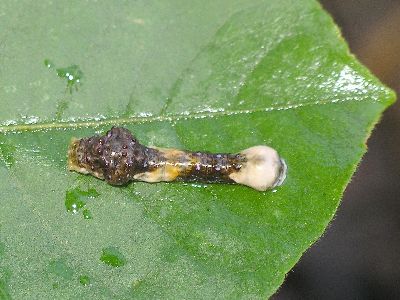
[68,127,288,190]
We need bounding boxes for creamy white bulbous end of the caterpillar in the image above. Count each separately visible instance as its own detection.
[229,146,286,191]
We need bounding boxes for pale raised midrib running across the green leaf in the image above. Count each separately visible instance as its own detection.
[0,99,381,134]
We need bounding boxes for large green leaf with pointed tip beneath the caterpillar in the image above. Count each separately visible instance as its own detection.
[0,0,394,299]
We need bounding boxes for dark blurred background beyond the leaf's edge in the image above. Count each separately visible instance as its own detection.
[273,0,400,300]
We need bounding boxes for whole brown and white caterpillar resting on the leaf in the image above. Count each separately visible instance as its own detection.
[68,127,287,191]
